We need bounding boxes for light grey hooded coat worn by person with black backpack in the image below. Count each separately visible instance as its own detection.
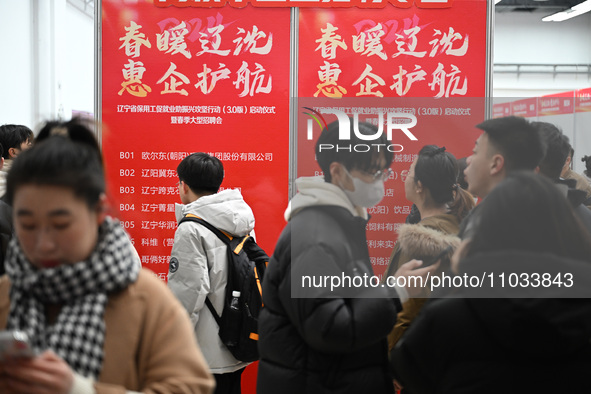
[168,189,254,374]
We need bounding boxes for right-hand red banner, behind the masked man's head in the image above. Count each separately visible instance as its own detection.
[297,0,487,275]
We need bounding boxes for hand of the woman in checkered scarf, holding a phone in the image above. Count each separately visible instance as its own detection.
[0,350,74,394]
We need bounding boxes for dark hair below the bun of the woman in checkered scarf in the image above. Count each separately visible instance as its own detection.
[6,136,105,207]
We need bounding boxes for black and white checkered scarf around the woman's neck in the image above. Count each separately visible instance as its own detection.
[5,217,140,379]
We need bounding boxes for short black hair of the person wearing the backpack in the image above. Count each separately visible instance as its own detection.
[176,152,224,194]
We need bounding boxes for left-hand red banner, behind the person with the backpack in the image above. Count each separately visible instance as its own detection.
[102,0,290,279]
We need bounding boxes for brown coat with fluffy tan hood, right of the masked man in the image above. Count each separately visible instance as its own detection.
[386,214,460,350]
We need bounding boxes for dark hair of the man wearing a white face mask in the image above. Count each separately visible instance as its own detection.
[315,118,394,182]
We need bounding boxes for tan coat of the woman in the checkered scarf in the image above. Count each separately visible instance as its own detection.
[0,270,214,394]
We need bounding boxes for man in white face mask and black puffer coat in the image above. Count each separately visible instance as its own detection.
[257,120,437,394]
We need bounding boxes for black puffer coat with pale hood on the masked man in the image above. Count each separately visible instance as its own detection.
[257,177,399,394]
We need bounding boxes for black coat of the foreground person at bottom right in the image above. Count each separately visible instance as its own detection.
[391,251,591,394]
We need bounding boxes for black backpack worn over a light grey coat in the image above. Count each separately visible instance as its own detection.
[179,214,269,362]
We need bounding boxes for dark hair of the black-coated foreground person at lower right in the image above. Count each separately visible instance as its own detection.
[467,171,591,262]
